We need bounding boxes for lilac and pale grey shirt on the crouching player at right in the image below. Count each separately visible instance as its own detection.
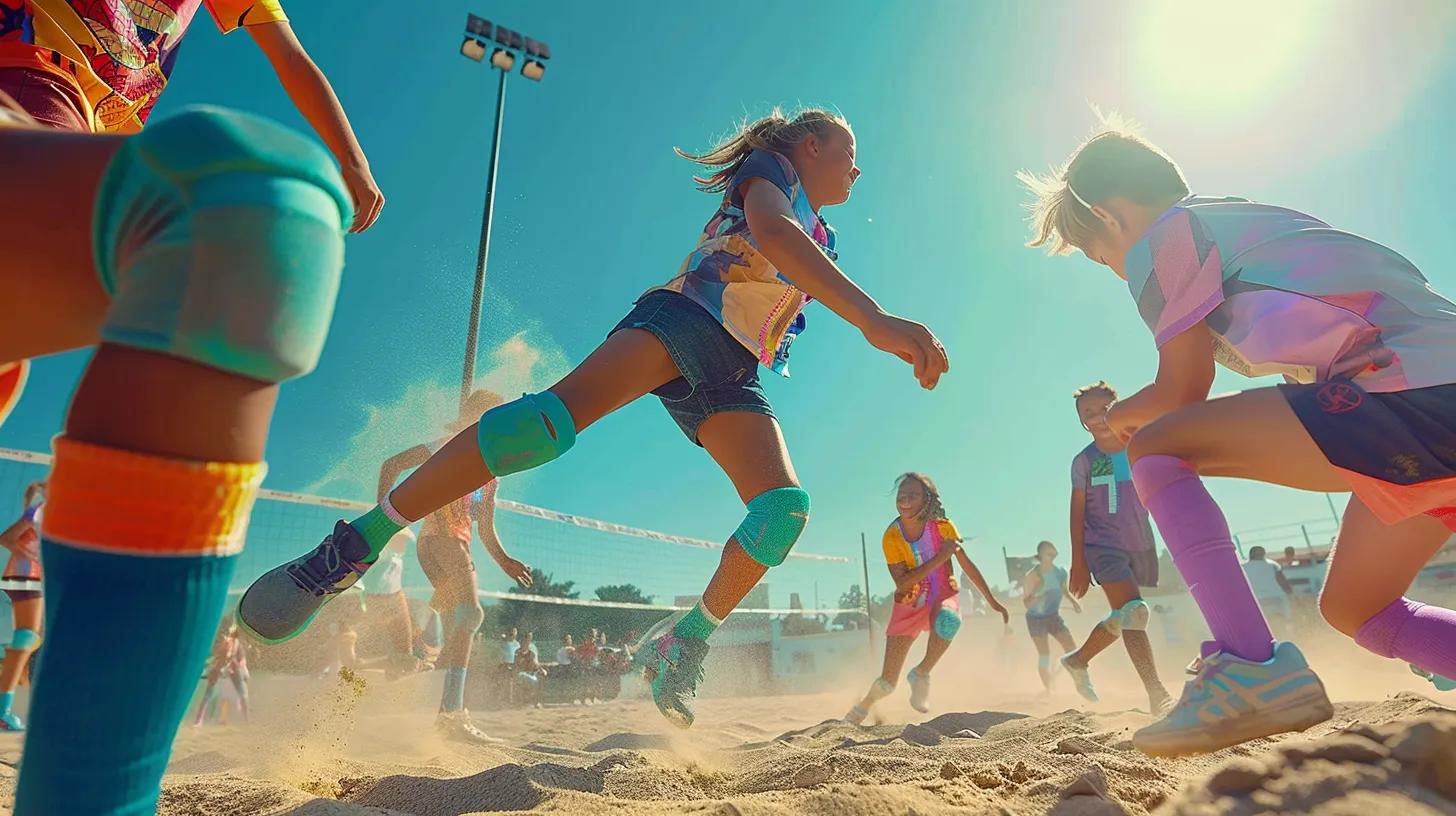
[1127,197,1456,392]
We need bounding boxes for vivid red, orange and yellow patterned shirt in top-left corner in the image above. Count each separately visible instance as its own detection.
[0,0,288,133]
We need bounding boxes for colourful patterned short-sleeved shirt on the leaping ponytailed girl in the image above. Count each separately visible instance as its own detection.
[649,150,836,376]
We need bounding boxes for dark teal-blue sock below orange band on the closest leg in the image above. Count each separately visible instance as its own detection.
[15,541,237,816]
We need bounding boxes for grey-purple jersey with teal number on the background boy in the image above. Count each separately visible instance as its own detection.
[1072,442,1153,552]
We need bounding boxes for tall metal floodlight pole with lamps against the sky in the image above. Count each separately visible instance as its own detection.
[460,15,550,405]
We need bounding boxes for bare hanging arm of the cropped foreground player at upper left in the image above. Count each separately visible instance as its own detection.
[248,20,384,232]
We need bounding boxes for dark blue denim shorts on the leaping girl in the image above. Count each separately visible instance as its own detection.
[609,290,773,444]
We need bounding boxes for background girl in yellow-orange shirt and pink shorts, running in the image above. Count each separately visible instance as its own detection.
[844,472,1010,726]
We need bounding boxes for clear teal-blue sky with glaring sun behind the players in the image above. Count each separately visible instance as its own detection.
[0,0,1456,592]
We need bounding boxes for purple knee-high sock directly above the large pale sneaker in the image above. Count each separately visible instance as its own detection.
[1133,455,1274,662]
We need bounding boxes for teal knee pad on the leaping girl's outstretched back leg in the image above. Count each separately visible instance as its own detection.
[476,391,577,476]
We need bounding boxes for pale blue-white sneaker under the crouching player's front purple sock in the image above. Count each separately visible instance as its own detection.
[1133,643,1335,756]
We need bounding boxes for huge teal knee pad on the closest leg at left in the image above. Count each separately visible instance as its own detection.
[93,108,354,382]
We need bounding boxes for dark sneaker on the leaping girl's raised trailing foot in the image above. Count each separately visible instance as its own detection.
[237,520,368,646]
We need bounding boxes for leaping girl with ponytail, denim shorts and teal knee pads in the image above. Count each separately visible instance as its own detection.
[239,109,949,727]
